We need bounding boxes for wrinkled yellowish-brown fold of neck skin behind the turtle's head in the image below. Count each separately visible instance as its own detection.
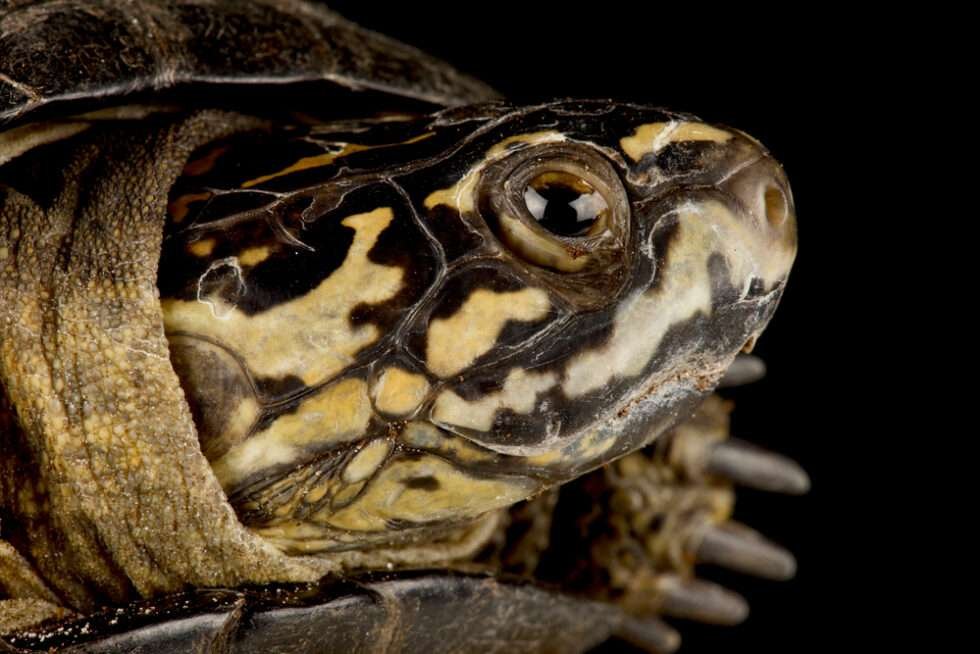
[0,112,328,610]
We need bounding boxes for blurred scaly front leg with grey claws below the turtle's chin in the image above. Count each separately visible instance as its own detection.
[488,392,809,652]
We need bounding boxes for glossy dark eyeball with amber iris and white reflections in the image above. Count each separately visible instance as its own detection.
[524,173,607,236]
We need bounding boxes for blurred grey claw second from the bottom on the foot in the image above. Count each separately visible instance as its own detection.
[656,574,749,625]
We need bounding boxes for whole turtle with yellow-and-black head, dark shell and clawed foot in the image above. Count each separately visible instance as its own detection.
[0,0,809,652]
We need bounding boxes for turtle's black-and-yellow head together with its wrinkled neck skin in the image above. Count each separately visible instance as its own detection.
[0,102,795,610]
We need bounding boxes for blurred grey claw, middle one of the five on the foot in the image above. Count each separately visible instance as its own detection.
[694,522,796,581]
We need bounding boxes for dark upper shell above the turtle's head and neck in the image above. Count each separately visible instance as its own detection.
[0,0,495,125]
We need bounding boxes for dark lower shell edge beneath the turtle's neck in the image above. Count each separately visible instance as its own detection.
[0,570,677,654]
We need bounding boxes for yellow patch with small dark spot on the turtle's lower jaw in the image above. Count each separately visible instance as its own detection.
[313,455,534,531]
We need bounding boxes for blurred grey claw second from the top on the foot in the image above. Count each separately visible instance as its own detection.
[704,438,810,495]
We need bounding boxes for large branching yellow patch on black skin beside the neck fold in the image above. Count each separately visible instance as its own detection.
[161,207,404,386]
